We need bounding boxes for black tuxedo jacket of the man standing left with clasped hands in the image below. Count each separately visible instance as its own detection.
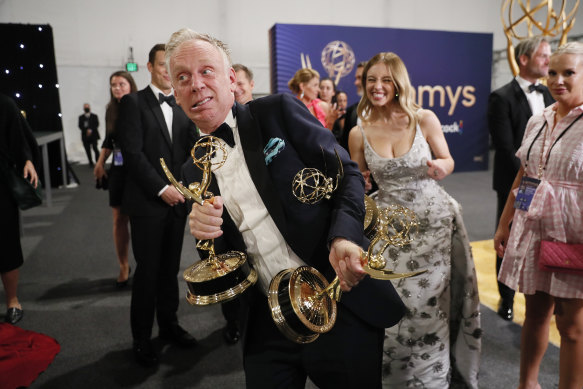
[115,86,197,216]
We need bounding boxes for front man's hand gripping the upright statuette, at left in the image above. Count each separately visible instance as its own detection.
[188,196,223,240]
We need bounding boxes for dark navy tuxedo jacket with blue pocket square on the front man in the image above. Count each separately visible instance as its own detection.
[183,94,405,328]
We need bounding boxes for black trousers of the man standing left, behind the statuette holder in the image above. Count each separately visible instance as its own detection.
[130,209,186,340]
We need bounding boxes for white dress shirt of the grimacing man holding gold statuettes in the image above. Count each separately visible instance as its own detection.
[202,110,305,294]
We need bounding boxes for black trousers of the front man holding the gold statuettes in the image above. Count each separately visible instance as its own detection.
[243,292,384,389]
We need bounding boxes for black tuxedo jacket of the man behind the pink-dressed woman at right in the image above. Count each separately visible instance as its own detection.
[488,79,555,193]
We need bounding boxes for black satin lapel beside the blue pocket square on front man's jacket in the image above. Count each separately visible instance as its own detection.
[236,103,292,236]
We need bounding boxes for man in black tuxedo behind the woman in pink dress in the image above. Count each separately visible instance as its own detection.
[488,36,554,320]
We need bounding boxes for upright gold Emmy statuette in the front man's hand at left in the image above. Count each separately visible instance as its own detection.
[160,136,257,305]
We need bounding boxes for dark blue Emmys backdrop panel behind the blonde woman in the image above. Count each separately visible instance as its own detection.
[269,24,492,171]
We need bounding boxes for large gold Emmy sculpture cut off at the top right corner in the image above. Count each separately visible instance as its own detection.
[501,0,579,76]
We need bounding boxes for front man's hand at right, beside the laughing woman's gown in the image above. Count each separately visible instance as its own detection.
[329,238,366,292]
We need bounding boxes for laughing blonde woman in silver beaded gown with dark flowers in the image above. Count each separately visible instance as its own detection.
[349,53,482,389]
